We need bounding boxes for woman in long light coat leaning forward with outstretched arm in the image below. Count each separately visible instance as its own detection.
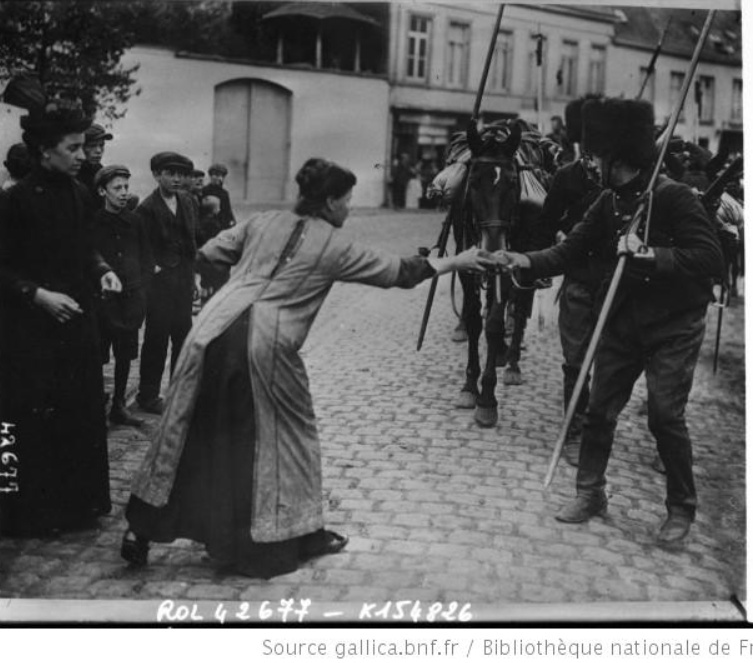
[121,159,488,578]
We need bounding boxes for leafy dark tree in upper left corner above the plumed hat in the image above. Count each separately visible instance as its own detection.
[0,0,140,121]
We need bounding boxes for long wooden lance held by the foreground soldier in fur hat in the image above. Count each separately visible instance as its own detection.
[544,9,716,488]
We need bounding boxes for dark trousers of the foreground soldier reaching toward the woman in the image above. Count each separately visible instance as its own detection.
[576,301,706,517]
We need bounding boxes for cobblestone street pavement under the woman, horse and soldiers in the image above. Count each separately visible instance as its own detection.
[0,211,746,619]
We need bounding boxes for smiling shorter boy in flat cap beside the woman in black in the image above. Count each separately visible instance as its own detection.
[92,165,154,426]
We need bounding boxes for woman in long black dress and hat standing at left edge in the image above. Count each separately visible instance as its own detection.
[0,84,120,536]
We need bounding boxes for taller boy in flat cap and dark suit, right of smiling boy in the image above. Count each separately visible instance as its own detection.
[136,152,198,414]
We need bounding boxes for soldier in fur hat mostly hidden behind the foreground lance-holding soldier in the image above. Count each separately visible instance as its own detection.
[541,97,605,465]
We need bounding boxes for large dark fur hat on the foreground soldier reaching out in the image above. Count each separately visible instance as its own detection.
[581,98,656,168]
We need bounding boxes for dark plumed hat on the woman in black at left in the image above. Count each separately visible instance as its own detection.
[3,73,92,149]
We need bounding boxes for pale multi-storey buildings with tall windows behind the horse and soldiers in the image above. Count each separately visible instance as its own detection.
[389,2,743,178]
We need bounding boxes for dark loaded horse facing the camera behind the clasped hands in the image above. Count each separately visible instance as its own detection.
[435,120,559,427]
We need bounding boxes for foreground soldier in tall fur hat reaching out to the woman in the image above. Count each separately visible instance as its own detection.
[499,99,723,545]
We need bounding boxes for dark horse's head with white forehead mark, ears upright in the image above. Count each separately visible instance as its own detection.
[467,123,521,251]
